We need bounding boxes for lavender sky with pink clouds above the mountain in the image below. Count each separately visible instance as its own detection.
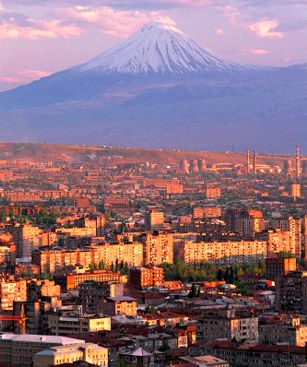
[0,0,307,91]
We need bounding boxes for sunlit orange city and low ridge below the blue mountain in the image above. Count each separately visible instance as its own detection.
[0,143,307,367]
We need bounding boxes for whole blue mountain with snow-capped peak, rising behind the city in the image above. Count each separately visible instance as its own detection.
[0,23,307,152]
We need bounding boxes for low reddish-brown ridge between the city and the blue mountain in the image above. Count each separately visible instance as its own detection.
[0,143,294,166]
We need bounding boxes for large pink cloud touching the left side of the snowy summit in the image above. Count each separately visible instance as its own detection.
[63,6,174,38]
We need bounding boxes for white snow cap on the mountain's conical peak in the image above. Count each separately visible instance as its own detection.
[77,23,245,74]
